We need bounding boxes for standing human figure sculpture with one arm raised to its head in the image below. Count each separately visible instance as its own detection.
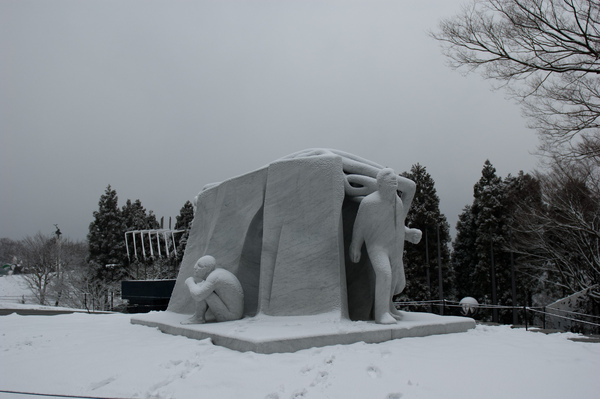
[350,168,421,324]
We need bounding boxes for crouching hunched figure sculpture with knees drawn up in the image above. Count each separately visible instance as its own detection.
[181,255,244,324]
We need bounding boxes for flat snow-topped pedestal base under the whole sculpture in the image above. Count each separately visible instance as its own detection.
[131,311,475,354]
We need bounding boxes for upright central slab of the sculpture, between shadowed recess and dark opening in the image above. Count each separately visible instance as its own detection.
[259,156,347,316]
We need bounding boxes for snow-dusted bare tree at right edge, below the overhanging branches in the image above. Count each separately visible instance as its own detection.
[513,156,600,300]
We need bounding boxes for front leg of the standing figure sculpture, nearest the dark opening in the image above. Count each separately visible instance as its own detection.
[369,250,396,324]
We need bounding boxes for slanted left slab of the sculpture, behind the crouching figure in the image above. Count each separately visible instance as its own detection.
[168,169,267,314]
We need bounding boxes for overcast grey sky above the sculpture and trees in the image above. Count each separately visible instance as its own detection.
[0,0,537,239]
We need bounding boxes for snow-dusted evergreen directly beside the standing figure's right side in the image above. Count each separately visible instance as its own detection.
[399,163,453,301]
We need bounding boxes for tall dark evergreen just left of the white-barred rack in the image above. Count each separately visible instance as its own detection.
[87,185,127,282]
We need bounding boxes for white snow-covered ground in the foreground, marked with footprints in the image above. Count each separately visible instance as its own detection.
[0,314,600,399]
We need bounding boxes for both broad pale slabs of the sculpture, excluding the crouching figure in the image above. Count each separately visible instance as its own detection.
[168,154,348,317]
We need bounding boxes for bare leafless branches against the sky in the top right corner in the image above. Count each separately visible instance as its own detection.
[432,0,600,162]
